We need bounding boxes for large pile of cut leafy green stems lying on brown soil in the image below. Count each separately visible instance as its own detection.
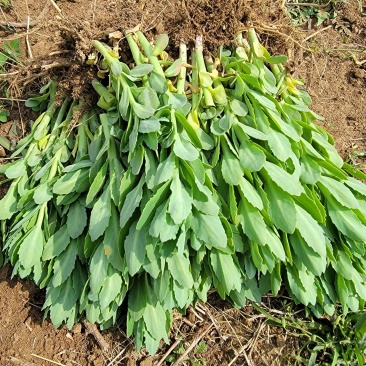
[0,30,366,352]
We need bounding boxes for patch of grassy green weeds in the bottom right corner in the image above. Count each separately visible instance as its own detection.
[253,300,366,366]
